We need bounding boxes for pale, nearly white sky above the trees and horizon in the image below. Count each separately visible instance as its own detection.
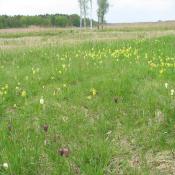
[0,0,175,22]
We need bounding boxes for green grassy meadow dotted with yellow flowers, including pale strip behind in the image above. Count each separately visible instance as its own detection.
[0,24,175,175]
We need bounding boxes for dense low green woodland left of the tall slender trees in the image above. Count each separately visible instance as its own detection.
[0,14,82,28]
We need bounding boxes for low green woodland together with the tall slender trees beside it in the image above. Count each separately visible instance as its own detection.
[0,0,109,29]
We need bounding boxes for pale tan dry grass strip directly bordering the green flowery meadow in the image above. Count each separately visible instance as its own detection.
[0,29,175,49]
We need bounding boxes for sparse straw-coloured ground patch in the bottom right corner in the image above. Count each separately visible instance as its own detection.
[105,128,175,175]
